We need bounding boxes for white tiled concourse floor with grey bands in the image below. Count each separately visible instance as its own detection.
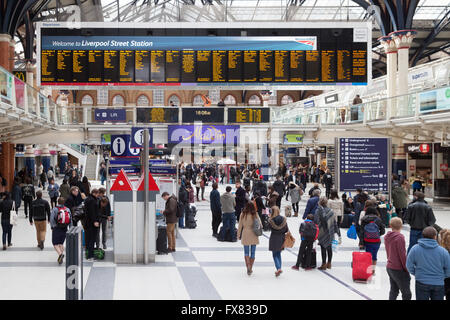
[0,180,450,300]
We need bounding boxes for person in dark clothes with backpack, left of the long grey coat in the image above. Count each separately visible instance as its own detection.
[291,214,319,270]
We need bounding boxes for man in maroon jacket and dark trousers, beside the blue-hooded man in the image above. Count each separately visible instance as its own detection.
[384,217,411,300]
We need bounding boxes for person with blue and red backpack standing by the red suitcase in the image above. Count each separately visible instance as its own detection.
[361,206,385,273]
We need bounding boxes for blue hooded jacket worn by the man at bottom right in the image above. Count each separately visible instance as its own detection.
[406,238,450,286]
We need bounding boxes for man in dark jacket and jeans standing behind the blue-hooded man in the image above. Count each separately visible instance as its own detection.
[404,191,436,253]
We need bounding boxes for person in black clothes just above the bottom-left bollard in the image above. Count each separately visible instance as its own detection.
[84,189,100,261]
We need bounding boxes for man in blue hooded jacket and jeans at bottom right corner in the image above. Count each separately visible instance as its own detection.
[406,227,450,300]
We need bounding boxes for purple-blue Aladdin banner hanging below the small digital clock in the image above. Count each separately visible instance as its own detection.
[168,125,239,145]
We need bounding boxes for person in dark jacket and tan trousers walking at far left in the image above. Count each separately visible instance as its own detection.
[30,190,50,250]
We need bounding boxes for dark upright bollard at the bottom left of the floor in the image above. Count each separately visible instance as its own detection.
[66,226,83,300]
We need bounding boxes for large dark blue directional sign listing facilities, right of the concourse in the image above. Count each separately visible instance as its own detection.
[339,138,392,192]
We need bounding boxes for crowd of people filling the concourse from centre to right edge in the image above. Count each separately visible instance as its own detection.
[163,165,450,300]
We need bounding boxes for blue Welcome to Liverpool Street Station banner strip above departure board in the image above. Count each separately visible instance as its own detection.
[41,36,317,50]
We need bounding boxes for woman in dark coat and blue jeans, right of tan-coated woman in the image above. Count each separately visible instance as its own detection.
[269,207,289,277]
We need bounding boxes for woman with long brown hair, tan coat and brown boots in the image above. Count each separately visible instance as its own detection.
[237,202,262,275]
